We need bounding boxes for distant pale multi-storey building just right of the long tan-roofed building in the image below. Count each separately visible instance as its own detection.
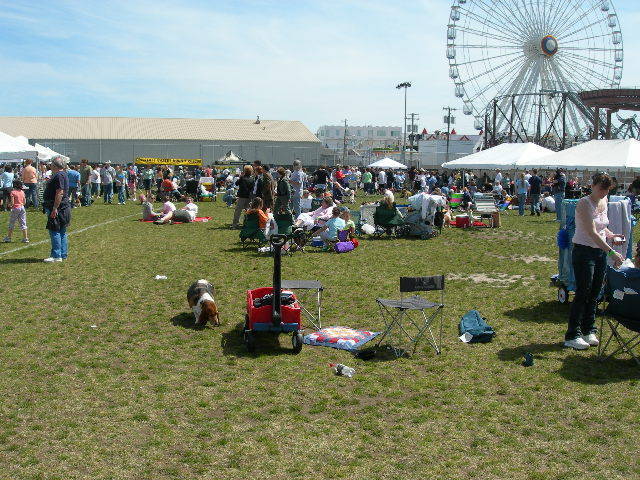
[316,125,402,152]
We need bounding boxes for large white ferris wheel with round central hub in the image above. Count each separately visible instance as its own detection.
[446,0,624,139]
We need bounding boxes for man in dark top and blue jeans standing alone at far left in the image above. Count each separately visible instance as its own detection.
[42,157,71,263]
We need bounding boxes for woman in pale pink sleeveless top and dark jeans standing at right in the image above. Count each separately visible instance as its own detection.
[556,173,625,350]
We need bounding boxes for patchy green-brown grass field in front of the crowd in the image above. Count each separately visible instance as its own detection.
[0,197,640,480]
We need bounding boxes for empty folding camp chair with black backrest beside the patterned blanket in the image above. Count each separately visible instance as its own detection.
[376,275,444,357]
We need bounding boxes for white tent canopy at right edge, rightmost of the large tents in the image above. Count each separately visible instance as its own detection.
[526,138,640,171]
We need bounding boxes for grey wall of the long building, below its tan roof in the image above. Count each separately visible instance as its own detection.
[30,139,320,166]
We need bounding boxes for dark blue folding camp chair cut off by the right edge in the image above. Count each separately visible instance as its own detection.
[598,268,640,366]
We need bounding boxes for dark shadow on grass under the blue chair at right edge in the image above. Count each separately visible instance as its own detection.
[558,349,640,385]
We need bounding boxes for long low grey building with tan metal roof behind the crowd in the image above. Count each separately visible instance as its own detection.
[0,117,321,166]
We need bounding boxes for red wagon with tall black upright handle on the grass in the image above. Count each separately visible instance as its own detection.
[243,235,302,353]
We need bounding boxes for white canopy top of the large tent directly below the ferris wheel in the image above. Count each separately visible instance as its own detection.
[442,143,554,170]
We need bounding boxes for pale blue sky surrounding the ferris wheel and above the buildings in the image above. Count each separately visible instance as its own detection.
[0,0,640,131]
